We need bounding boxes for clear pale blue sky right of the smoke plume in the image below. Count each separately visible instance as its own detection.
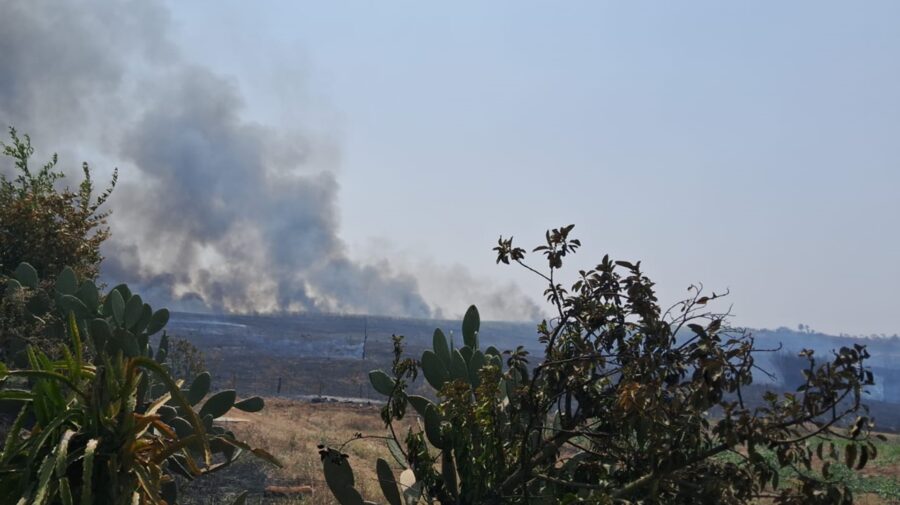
[162,1,900,334]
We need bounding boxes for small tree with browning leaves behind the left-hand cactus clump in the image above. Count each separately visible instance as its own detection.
[0,128,118,362]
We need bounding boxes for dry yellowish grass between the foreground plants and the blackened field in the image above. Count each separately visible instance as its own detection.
[182,398,900,505]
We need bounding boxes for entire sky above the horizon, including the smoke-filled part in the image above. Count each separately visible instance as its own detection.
[0,0,900,334]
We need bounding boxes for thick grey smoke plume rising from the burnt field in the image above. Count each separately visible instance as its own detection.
[0,0,533,317]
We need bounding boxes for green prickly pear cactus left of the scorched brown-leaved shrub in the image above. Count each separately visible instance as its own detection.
[319,305,518,505]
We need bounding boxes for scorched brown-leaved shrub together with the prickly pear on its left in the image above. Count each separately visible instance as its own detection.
[320,226,875,505]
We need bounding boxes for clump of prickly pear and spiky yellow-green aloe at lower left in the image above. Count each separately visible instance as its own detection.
[0,264,277,505]
